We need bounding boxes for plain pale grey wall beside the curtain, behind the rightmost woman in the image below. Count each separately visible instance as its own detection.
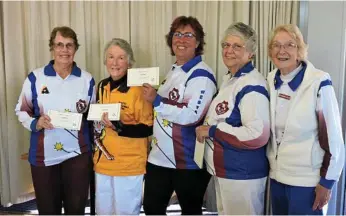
[303,1,346,110]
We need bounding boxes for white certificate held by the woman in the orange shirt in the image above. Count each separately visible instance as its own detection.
[87,103,121,121]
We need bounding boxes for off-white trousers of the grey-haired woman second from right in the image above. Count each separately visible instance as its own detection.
[214,176,267,215]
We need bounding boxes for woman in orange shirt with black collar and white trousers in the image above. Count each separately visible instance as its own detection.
[94,38,153,215]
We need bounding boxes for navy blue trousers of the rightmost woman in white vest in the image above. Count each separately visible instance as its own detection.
[270,179,323,215]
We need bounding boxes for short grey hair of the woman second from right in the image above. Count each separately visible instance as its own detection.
[221,22,257,54]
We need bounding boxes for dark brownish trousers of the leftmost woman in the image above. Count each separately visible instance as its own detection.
[31,153,92,215]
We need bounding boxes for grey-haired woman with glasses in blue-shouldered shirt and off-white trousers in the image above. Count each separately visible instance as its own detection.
[196,22,270,215]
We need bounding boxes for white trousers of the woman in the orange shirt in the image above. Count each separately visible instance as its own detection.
[95,173,143,215]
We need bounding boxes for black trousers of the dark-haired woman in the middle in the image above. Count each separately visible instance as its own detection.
[143,163,211,215]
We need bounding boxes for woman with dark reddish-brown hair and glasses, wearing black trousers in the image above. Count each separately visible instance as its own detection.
[143,16,216,215]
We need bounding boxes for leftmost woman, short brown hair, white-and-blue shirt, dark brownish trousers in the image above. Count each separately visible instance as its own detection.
[16,26,95,215]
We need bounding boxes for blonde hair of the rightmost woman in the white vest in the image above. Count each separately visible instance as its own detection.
[268,24,308,60]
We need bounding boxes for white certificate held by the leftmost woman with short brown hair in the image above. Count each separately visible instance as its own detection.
[48,110,83,130]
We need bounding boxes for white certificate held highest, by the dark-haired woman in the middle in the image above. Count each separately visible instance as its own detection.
[127,67,160,86]
